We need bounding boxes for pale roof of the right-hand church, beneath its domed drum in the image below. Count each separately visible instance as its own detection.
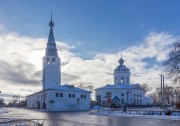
[95,84,144,90]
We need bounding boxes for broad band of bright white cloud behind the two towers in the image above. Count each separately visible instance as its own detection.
[0,23,178,102]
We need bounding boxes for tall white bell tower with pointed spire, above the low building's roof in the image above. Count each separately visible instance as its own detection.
[42,13,61,90]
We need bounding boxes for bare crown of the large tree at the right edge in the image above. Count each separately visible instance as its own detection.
[163,42,180,83]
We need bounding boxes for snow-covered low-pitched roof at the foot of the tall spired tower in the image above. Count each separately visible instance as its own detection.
[26,84,91,97]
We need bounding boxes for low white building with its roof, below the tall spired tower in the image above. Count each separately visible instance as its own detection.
[27,85,91,111]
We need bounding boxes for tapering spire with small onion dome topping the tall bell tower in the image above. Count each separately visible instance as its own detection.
[46,12,58,56]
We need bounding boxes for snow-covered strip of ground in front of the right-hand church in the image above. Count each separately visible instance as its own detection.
[90,108,180,120]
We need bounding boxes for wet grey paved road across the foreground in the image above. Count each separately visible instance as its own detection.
[0,108,180,126]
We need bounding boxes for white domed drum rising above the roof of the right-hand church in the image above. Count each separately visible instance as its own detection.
[114,55,131,85]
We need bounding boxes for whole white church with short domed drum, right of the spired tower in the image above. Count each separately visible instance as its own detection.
[95,56,153,107]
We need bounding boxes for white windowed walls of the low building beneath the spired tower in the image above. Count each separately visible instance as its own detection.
[27,90,90,111]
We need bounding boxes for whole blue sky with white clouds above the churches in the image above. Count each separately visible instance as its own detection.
[0,0,180,100]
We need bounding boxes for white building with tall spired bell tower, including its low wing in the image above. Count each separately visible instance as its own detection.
[27,16,91,111]
